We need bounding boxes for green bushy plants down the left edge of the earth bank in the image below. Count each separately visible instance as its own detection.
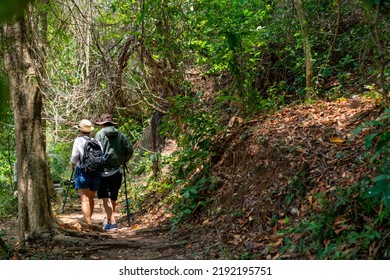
[163,94,220,229]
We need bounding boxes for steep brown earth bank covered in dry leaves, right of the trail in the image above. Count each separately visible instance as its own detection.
[168,97,389,259]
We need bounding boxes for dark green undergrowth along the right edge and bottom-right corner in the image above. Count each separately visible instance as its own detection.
[279,109,390,259]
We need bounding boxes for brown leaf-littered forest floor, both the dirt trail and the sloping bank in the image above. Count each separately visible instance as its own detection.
[0,94,382,260]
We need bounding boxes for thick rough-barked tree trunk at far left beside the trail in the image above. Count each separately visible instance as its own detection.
[2,18,54,248]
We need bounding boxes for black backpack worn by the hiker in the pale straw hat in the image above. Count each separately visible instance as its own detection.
[80,136,103,174]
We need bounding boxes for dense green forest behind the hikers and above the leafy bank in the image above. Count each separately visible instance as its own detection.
[0,0,390,257]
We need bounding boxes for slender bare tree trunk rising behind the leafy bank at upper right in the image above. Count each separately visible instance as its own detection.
[294,0,313,88]
